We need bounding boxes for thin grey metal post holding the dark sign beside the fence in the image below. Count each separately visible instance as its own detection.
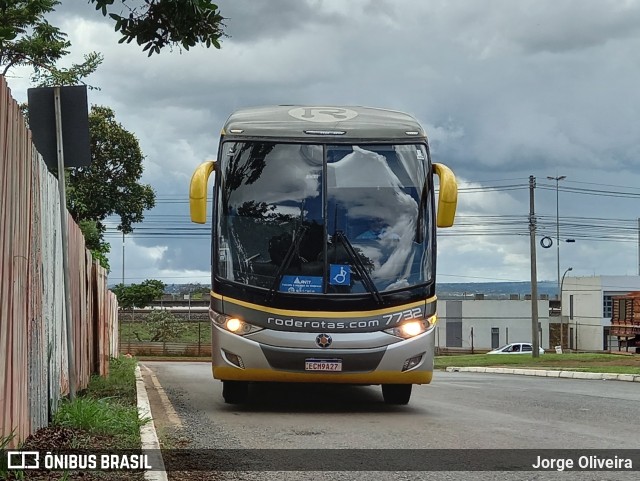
[53,87,76,401]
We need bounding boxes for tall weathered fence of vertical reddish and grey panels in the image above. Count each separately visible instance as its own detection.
[0,76,118,446]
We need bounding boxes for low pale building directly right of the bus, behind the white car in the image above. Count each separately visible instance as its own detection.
[436,298,552,351]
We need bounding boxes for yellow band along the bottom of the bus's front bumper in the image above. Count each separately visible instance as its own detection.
[212,366,433,384]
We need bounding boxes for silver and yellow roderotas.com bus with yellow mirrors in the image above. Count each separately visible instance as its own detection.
[190,105,457,404]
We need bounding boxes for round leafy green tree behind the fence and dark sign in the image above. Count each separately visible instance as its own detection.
[67,105,155,234]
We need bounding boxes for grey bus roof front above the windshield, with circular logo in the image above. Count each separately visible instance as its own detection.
[222,105,426,141]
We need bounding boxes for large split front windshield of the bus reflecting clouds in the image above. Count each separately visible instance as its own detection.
[214,141,435,297]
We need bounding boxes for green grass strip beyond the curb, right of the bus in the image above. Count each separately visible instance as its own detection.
[435,354,640,375]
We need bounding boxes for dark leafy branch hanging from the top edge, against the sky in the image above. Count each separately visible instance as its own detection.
[90,0,225,56]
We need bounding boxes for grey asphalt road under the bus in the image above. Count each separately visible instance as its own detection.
[143,362,640,480]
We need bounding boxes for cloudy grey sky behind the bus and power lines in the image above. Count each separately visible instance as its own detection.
[8,0,640,284]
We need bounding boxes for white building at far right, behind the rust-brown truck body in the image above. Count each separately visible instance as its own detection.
[562,276,640,351]
